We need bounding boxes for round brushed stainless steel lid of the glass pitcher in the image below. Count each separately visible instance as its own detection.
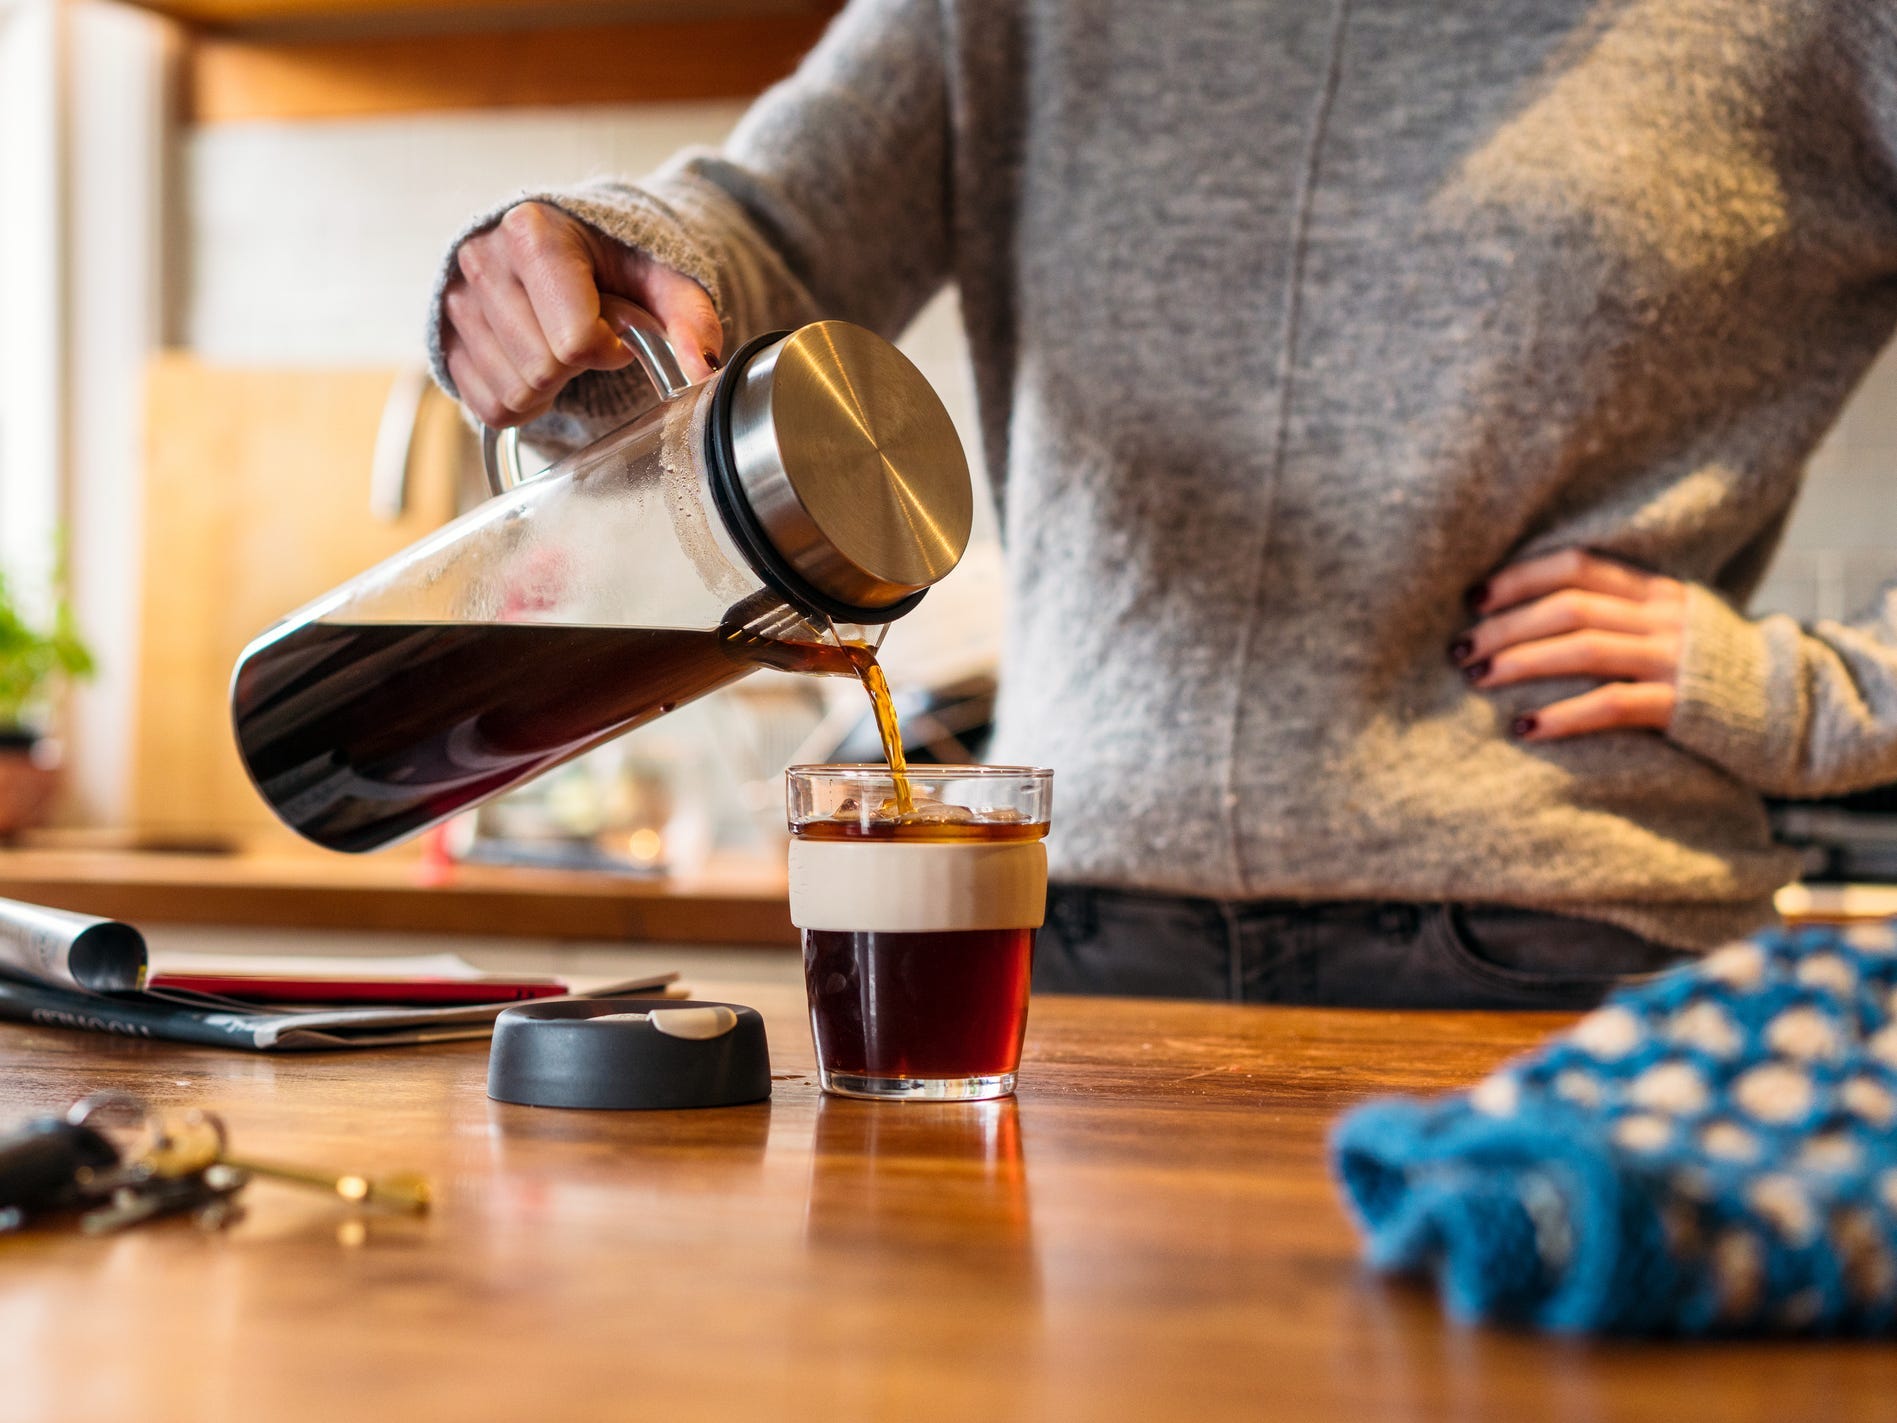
[727,321,975,609]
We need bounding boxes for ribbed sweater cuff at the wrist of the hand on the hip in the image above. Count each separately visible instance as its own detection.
[1667,584,1804,791]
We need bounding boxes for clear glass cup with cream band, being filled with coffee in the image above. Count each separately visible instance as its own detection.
[787,767,1053,1100]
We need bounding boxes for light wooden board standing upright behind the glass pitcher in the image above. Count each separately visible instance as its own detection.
[131,353,478,844]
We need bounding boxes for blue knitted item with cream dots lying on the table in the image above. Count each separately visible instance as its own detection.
[1332,928,1897,1336]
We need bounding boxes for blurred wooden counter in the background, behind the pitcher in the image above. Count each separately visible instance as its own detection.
[0,848,797,945]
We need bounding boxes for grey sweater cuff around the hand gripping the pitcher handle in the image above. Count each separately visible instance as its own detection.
[429,180,728,448]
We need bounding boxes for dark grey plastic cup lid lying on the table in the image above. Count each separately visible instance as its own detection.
[488,998,770,1110]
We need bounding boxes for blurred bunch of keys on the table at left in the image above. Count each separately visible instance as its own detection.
[0,1093,431,1235]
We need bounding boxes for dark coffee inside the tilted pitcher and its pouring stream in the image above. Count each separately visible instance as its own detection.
[231,622,907,852]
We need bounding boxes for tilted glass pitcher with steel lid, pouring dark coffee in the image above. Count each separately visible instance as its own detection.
[231,298,973,850]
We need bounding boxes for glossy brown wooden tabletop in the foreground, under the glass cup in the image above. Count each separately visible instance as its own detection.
[0,985,1897,1423]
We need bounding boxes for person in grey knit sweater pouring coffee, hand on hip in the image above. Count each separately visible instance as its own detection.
[433,0,1897,1007]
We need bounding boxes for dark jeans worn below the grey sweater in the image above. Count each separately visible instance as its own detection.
[1034,884,1686,1009]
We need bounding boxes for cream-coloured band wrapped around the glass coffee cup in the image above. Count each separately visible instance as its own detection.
[791,839,1047,933]
